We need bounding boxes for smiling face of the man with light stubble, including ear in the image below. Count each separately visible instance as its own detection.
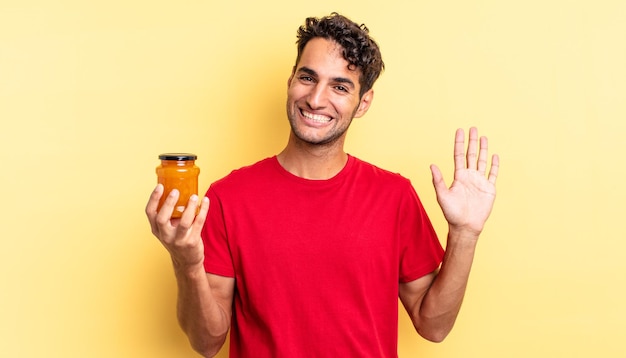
[287,38,373,145]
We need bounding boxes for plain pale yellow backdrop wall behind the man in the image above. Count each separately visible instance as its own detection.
[0,0,626,358]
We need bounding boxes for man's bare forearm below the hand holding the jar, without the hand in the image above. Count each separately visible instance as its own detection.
[174,265,230,357]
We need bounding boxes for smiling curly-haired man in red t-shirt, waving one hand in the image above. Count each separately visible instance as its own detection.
[146,13,499,357]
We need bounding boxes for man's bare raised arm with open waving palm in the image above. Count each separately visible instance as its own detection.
[399,128,500,342]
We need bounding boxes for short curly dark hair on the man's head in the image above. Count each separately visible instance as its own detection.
[296,12,385,96]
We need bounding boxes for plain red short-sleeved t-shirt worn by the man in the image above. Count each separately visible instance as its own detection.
[202,156,443,358]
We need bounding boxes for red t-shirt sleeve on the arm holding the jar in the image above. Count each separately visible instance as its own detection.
[202,186,235,277]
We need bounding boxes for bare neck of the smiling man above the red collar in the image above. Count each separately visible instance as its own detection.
[277,135,348,180]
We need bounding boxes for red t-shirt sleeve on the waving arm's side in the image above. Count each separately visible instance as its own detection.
[398,183,444,283]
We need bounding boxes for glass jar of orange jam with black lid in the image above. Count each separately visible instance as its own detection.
[156,153,200,218]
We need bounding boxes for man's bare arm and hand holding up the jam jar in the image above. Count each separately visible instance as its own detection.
[146,185,235,357]
